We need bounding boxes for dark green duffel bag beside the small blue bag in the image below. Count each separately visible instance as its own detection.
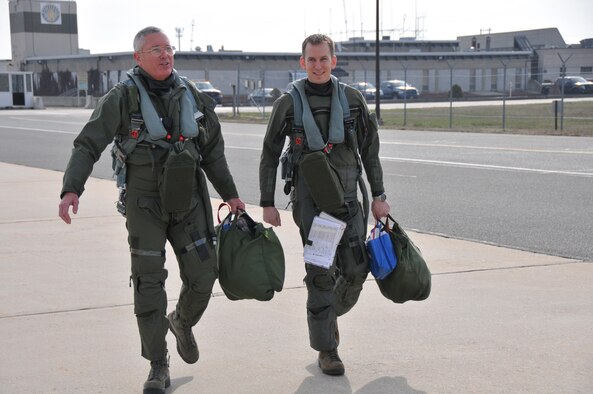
[376,215,431,304]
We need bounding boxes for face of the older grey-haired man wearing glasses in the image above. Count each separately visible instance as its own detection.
[134,33,173,81]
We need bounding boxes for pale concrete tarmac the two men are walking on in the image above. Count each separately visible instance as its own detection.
[0,163,593,394]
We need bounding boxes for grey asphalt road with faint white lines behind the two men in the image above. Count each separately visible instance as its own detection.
[0,109,593,261]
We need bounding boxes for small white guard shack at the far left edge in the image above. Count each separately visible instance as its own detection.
[0,71,33,108]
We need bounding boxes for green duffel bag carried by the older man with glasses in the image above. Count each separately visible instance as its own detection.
[216,204,285,301]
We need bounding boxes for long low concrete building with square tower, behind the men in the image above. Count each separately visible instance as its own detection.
[4,0,593,105]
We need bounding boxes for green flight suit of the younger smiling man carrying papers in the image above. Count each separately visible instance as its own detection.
[259,82,384,351]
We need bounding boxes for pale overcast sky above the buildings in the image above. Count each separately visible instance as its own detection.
[0,0,593,59]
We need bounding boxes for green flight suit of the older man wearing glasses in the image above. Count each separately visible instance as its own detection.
[61,70,238,360]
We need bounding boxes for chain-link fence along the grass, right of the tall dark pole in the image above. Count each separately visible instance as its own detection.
[346,65,593,135]
